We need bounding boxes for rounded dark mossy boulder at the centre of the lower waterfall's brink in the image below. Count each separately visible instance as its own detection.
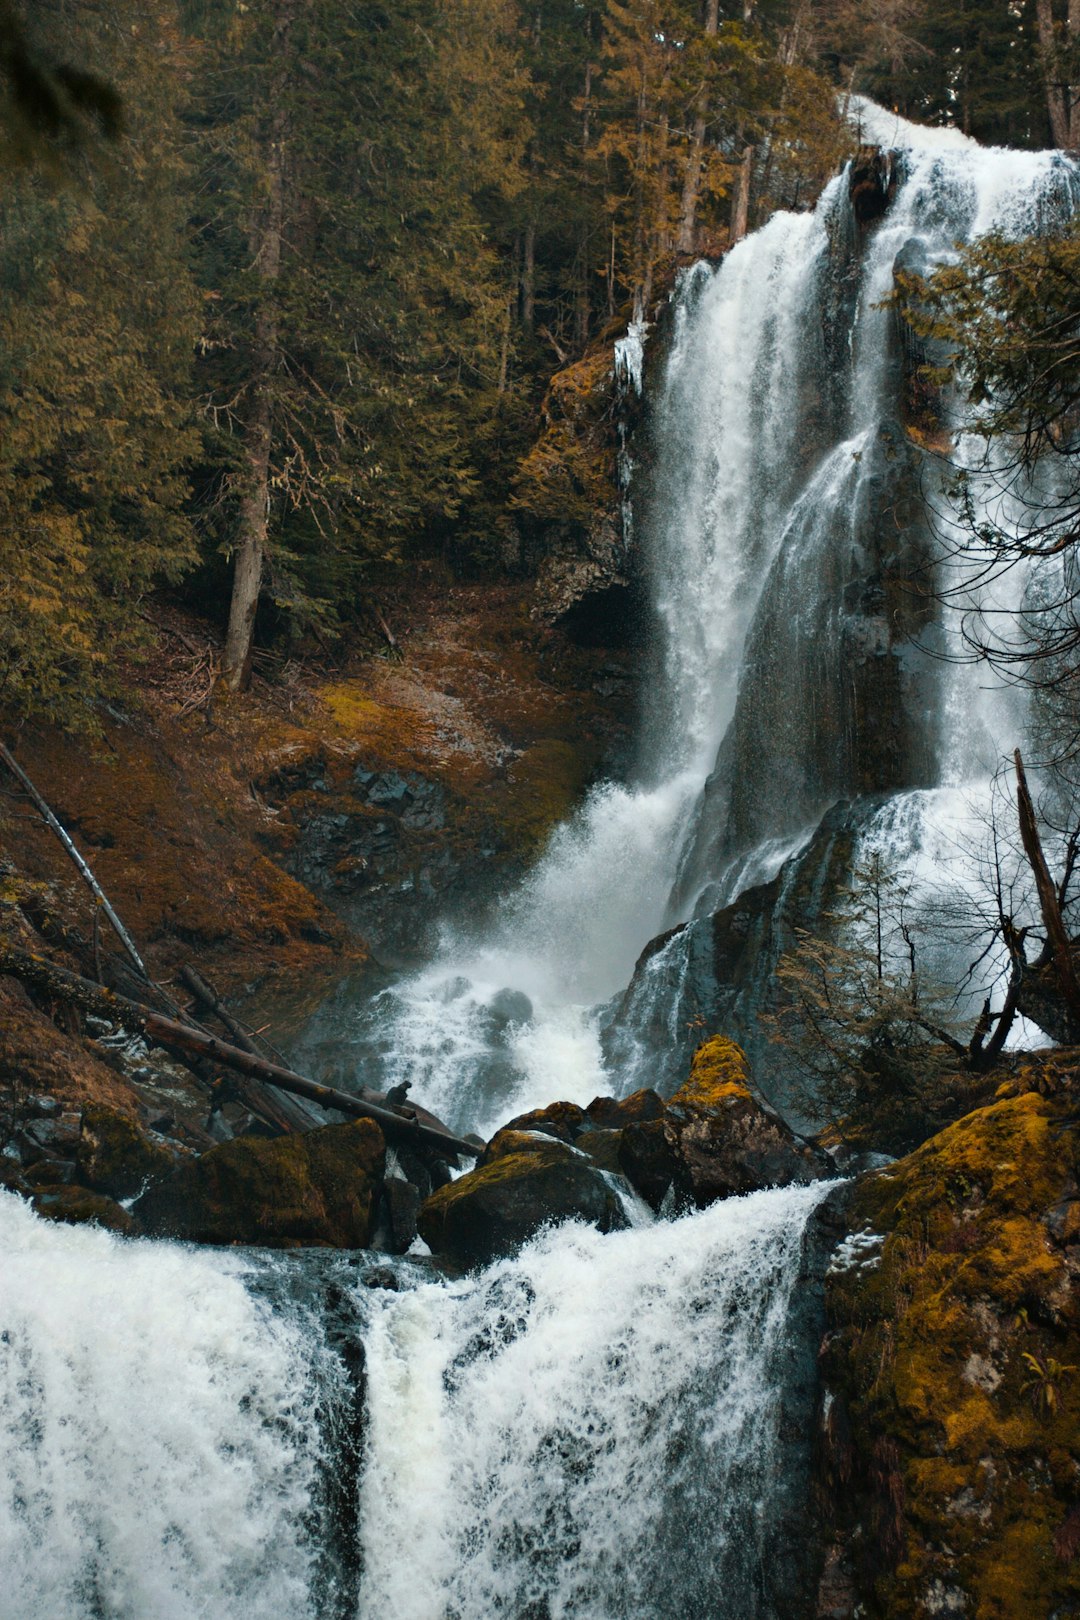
[419,1140,628,1265]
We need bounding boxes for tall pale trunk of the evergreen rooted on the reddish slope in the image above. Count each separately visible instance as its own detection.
[222,0,296,692]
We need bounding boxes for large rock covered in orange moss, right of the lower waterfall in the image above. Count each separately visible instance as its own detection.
[821,1082,1080,1620]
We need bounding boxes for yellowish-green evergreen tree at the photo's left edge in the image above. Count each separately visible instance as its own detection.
[0,0,196,721]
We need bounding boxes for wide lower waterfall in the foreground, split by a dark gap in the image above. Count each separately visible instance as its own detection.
[0,1186,827,1620]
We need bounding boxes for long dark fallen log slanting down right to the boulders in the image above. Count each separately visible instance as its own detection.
[0,940,481,1158]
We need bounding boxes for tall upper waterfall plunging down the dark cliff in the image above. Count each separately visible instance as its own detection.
[306,97,1078,1132]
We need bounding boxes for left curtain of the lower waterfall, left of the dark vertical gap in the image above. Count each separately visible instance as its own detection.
[0,1192,319,1620]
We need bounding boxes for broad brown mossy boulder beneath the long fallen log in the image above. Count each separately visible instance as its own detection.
[136,1119,385,1249]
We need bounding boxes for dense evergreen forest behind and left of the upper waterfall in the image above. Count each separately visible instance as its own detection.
[0,0,1072,718]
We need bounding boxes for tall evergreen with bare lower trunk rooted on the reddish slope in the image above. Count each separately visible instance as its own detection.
[199,0,523,687]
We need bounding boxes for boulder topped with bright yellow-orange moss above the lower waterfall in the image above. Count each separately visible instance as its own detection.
[664,1035,832,1209]
